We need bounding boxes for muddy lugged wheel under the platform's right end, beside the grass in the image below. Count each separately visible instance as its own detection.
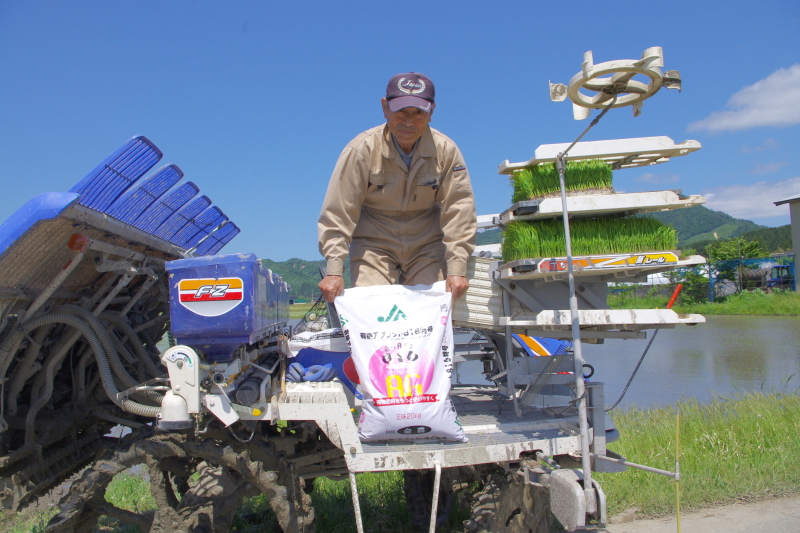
[464,472,553,533]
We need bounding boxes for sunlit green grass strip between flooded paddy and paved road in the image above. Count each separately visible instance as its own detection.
[596,393,800,517]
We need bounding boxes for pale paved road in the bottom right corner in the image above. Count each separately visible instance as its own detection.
[590,496,800,533]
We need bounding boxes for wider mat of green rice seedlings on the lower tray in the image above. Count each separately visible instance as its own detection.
[502,217,678,261]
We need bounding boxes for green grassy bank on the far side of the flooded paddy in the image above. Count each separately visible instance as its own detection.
[608,291,800,316]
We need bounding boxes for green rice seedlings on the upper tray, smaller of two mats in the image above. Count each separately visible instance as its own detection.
[511,159,613,202]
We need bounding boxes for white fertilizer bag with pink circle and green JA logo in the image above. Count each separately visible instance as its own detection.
[336,281,467,442]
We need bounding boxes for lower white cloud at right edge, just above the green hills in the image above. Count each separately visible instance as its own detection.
[703,177,800,220]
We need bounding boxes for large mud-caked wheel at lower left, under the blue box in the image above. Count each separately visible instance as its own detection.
[46,426,314,533]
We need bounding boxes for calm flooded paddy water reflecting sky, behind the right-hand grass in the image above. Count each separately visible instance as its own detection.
[583,316,800,406]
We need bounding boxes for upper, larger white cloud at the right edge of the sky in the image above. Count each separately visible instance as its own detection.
[688,63,800,132]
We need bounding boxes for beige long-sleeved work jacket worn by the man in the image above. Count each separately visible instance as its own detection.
[317,124,477,276]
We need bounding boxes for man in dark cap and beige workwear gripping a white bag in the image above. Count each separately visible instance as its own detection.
[318,72,477,302]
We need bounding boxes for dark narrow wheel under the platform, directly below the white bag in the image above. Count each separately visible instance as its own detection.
[403,470,453,531]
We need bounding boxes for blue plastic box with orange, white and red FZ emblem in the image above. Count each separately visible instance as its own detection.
[166,254,289,362]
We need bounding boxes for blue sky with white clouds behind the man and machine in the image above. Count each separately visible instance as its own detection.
[0,0,800,261]
